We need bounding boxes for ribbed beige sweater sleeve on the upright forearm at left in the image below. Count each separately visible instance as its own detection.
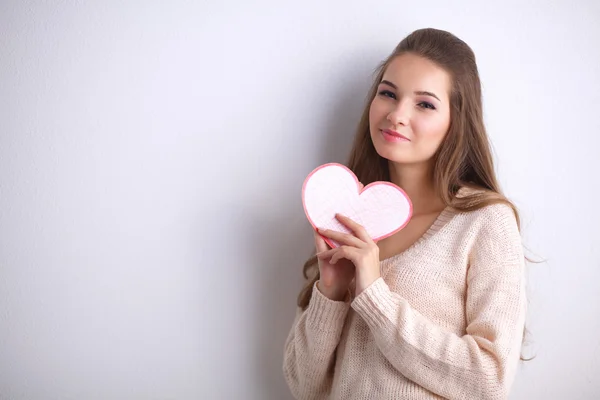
[283,283,350,399]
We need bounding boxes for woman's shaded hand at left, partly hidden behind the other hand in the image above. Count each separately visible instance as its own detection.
[315,232,355,301]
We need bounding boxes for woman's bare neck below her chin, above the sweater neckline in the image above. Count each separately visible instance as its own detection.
[389,161,444,215]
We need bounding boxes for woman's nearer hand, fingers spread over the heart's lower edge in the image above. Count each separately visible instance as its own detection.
[317,214,381,296]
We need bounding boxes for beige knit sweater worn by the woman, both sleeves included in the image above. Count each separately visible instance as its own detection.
[283,205,526,400]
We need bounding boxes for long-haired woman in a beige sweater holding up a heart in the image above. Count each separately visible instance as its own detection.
[283,29,526,399]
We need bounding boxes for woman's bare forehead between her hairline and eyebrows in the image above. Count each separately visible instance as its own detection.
[383,53,451,97]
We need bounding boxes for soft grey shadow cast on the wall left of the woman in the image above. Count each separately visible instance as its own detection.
[247,57,377,400]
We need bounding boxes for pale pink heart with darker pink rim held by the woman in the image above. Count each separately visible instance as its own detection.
[302,163,412,248]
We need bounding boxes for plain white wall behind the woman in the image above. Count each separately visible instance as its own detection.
[0,0,600,400]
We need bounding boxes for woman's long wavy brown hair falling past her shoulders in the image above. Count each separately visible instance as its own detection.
[298,28,536,360]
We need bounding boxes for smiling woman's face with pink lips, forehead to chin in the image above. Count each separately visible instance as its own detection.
[369,53,451,164]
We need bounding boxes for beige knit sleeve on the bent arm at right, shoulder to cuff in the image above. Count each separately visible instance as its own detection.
[352,205,526,399]
